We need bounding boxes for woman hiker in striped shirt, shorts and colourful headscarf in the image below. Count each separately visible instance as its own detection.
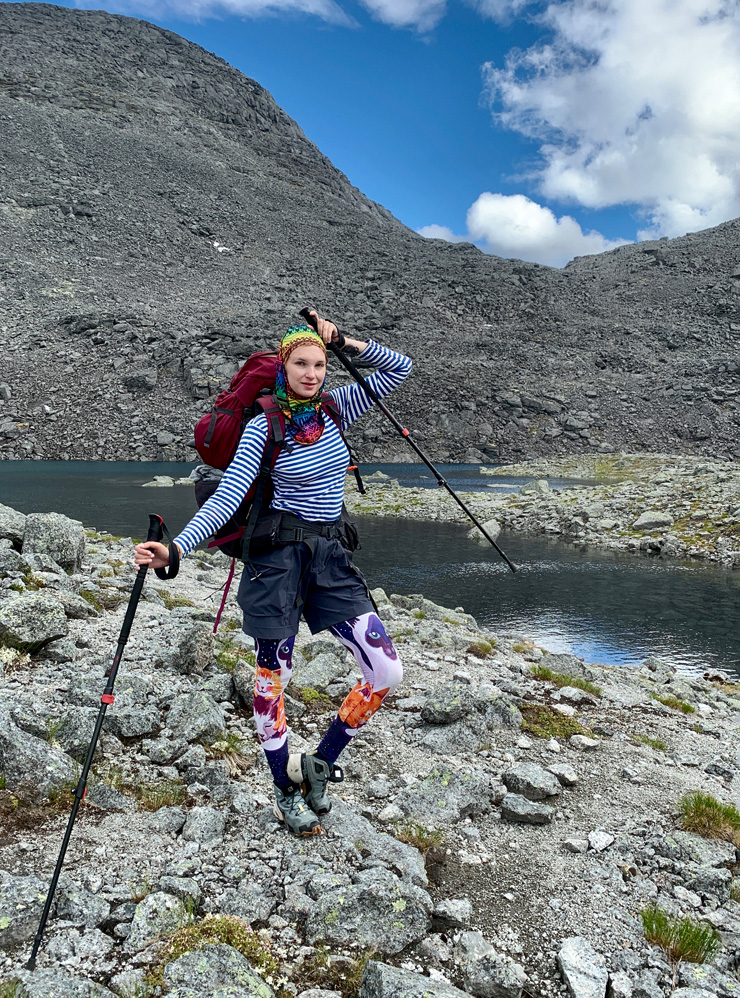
[135,312,411,836]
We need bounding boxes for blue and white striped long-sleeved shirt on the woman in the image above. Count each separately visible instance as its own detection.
[175,340,411,555]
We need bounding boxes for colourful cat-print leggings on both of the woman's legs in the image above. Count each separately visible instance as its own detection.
[254,613,403,786]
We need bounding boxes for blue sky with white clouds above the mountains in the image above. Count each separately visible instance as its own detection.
[26,0,740,266]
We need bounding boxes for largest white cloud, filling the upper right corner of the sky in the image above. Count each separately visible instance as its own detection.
[479,0,740,237]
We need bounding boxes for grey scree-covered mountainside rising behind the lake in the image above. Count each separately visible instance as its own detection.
[0,3,740,462]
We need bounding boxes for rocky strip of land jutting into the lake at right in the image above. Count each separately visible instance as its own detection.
[345,454,740,568]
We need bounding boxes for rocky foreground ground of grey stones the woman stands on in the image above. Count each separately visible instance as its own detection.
[0,507,740,998]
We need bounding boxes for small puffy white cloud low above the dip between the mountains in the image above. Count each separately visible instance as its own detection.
[417,191,625,267]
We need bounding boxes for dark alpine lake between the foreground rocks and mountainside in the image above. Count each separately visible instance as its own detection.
[0,461,740,674]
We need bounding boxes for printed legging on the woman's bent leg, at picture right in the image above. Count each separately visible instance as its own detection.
[317,613,403,765]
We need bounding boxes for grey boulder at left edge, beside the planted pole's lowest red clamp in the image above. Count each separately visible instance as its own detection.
[0,707,77,803]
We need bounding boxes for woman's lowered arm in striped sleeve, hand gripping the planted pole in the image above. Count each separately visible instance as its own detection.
[135,416,267,568]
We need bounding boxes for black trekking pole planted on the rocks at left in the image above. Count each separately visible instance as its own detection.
[26,513,180,970]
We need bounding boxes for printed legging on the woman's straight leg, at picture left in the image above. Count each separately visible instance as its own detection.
[253,637,295,787]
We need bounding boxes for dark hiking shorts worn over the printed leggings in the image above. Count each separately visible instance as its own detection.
[237,537,375,639]
